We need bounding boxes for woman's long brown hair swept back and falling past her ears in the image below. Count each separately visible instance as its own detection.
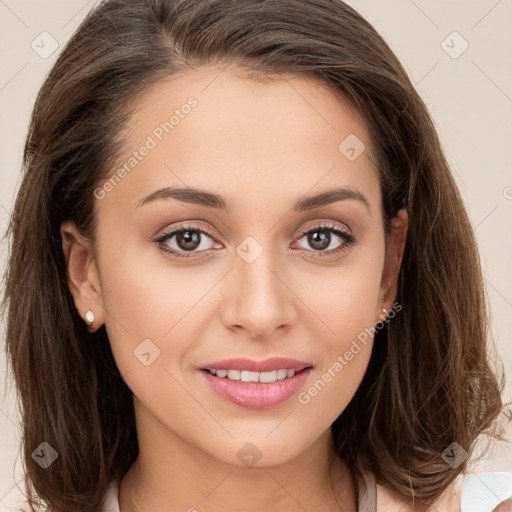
[3,0,503,512]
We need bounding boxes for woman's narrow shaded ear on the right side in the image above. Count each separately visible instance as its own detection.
[376,208,409,321]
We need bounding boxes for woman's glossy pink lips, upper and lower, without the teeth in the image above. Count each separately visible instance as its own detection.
[200,357,312,409]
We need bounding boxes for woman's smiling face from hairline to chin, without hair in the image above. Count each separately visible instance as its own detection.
[62,67,401,465]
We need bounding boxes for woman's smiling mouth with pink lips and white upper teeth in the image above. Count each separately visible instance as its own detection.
[200,358,313,409]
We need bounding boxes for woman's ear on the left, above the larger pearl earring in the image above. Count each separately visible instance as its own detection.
[60,221,105,332]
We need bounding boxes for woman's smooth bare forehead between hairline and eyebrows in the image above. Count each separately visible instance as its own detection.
[100,66,378,216]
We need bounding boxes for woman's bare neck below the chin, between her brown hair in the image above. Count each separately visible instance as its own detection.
[119,400,356,512]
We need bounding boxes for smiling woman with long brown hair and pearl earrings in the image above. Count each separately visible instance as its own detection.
[5,0,508,512]
